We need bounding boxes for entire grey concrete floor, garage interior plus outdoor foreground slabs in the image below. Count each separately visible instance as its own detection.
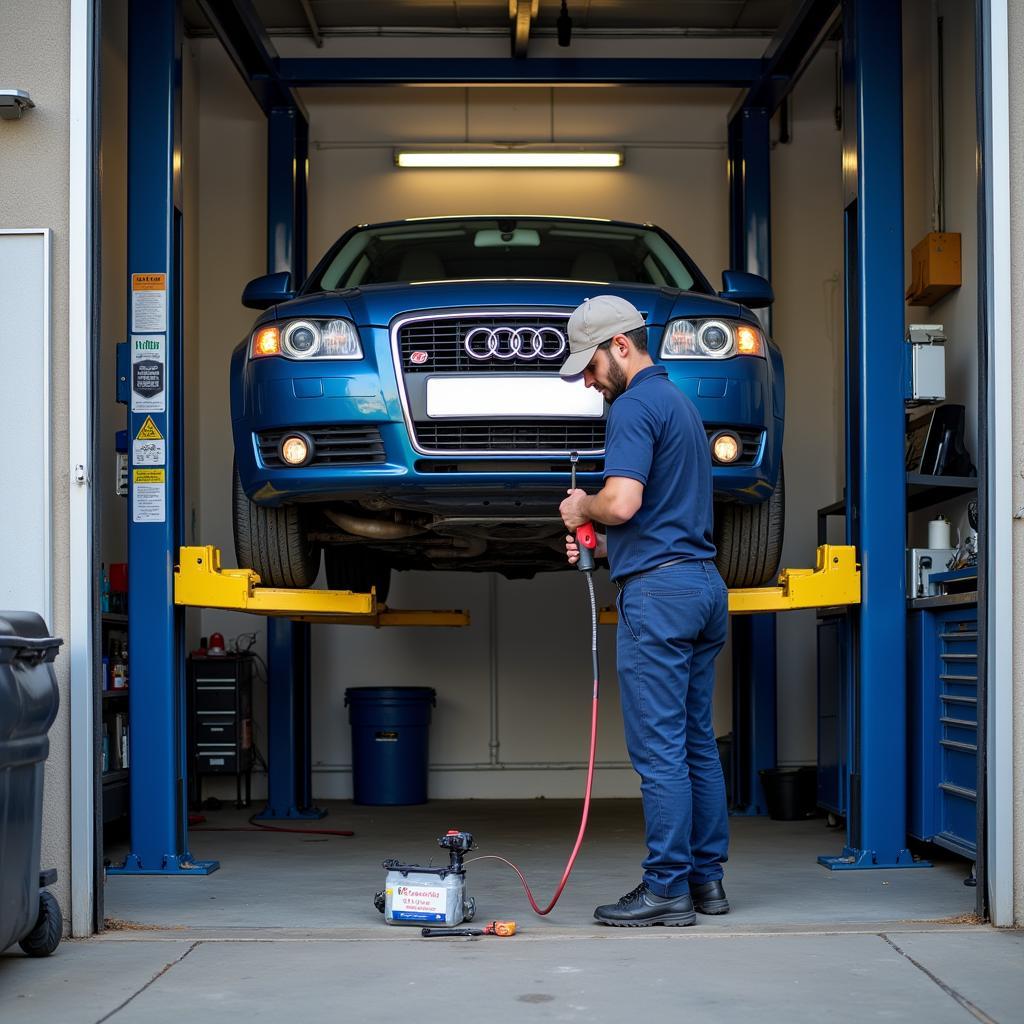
[0,801,1024,1024]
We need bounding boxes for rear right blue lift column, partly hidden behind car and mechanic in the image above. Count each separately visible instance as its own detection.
[729,106,777,814]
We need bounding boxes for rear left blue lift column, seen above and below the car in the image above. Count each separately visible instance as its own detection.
[256,106,327,821]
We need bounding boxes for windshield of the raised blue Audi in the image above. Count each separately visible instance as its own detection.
[305,218,707,292]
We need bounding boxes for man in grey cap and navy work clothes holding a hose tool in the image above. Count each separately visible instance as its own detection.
[559,295,729,927]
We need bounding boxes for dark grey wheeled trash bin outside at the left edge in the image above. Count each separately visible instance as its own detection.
[0,611,63,956]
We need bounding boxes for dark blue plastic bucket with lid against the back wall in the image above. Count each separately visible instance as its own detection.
[345,686,437,805]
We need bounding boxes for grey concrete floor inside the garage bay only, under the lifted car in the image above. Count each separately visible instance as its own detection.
[104,800,975,941]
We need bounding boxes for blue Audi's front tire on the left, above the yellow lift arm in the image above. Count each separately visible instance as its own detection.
[231,466,321,589]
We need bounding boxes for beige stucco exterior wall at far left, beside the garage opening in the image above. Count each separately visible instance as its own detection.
[0,0,72,929]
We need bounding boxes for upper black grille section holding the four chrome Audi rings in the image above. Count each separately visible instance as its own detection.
[398,313,568,375]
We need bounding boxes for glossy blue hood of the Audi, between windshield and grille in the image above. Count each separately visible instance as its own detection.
[273,280,752,327]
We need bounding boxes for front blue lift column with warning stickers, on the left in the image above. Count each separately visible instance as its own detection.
[108,0,218,874]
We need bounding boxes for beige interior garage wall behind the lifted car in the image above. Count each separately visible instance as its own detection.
[194,34,842,798]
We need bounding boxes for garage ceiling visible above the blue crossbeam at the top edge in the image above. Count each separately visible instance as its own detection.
[183,0,798,36]
